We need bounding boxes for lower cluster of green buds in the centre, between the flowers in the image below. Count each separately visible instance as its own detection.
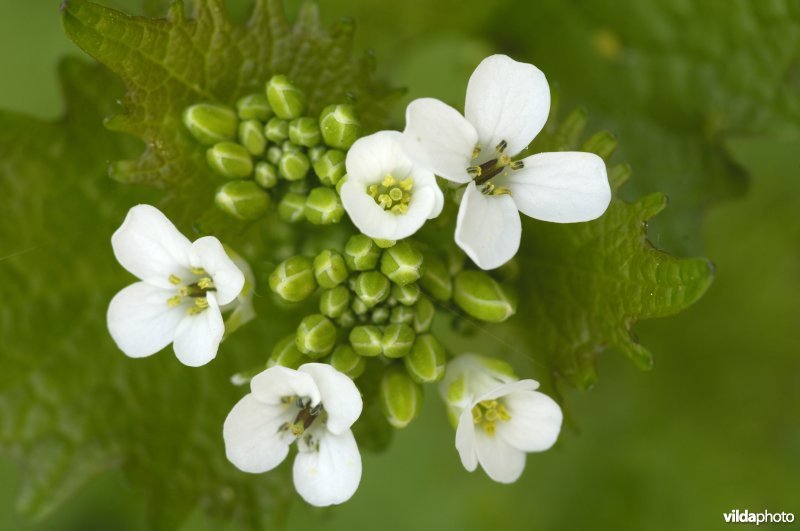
[268,234,516,428]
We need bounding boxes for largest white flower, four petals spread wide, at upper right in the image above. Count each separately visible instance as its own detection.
[403,55,611,269]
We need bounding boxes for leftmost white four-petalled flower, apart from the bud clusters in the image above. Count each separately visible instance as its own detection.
[107,205,244,367]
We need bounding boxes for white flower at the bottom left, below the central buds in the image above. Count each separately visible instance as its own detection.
[223,363,362,507]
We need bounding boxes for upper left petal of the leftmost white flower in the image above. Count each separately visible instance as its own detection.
[111,205,191,288]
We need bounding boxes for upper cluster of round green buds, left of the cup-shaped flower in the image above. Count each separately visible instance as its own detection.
[183,75,361,225]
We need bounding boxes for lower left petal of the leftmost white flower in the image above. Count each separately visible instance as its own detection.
[106,282,181,358]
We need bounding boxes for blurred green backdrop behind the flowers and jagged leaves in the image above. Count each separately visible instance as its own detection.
[0,0,800,531]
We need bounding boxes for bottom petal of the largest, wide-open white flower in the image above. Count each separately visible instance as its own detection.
[456,182,522,269]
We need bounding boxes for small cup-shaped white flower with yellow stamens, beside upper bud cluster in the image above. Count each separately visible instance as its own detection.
[341,131,444,240]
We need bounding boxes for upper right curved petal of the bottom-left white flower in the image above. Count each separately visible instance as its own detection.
[297,363,362,434]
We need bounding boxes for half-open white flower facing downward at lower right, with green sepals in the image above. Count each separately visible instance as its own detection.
[439,354,562,483]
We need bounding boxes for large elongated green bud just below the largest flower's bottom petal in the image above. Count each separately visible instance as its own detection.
[453,270,517,323]
